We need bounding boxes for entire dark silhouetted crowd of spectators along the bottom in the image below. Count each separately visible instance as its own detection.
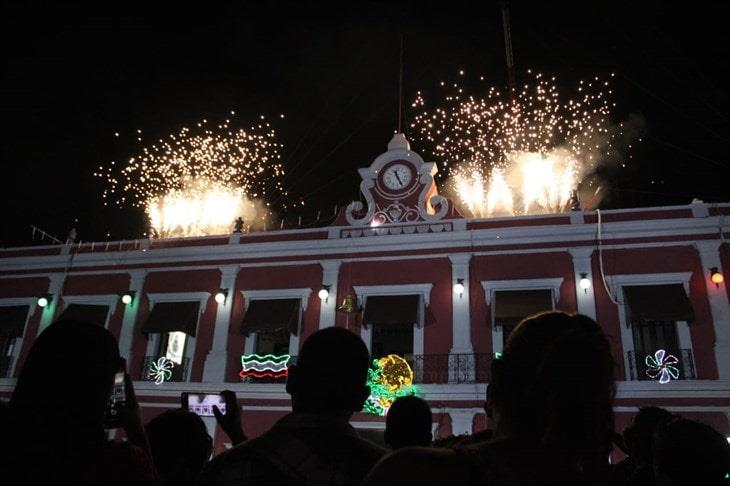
[0,312,730,486]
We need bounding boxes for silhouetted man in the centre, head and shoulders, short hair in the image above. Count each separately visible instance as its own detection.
[193,327,387,486]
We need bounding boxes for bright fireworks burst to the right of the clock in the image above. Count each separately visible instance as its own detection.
[411,71,620,217]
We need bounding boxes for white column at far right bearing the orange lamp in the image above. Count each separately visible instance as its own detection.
[695,240,730,380]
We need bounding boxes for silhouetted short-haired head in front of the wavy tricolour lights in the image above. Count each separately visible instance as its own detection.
[286,327,370,415]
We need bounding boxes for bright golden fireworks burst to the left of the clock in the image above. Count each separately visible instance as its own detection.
[94,112,286,237]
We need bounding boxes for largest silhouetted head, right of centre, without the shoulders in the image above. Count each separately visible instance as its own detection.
[486,312,615,471]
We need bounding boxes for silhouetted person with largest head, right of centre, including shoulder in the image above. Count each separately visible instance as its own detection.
[363,312,614,486]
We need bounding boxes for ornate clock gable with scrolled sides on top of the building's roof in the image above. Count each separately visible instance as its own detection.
[345,133,462,227]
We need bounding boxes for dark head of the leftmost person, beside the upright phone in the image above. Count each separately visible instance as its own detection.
[10,321,121,429]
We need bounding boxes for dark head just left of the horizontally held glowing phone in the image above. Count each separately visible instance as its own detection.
[145,409,213,485]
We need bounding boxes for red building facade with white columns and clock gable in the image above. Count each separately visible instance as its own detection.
[0,136,730,450]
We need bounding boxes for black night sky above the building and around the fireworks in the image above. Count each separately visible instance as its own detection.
[0,0,730,246]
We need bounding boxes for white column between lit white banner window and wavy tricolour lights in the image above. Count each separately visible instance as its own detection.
[203,265,240,383]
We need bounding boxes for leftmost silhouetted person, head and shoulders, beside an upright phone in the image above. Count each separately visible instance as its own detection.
[0,321,159,485]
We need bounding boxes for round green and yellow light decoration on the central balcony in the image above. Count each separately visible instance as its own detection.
[363,354,418,416]
